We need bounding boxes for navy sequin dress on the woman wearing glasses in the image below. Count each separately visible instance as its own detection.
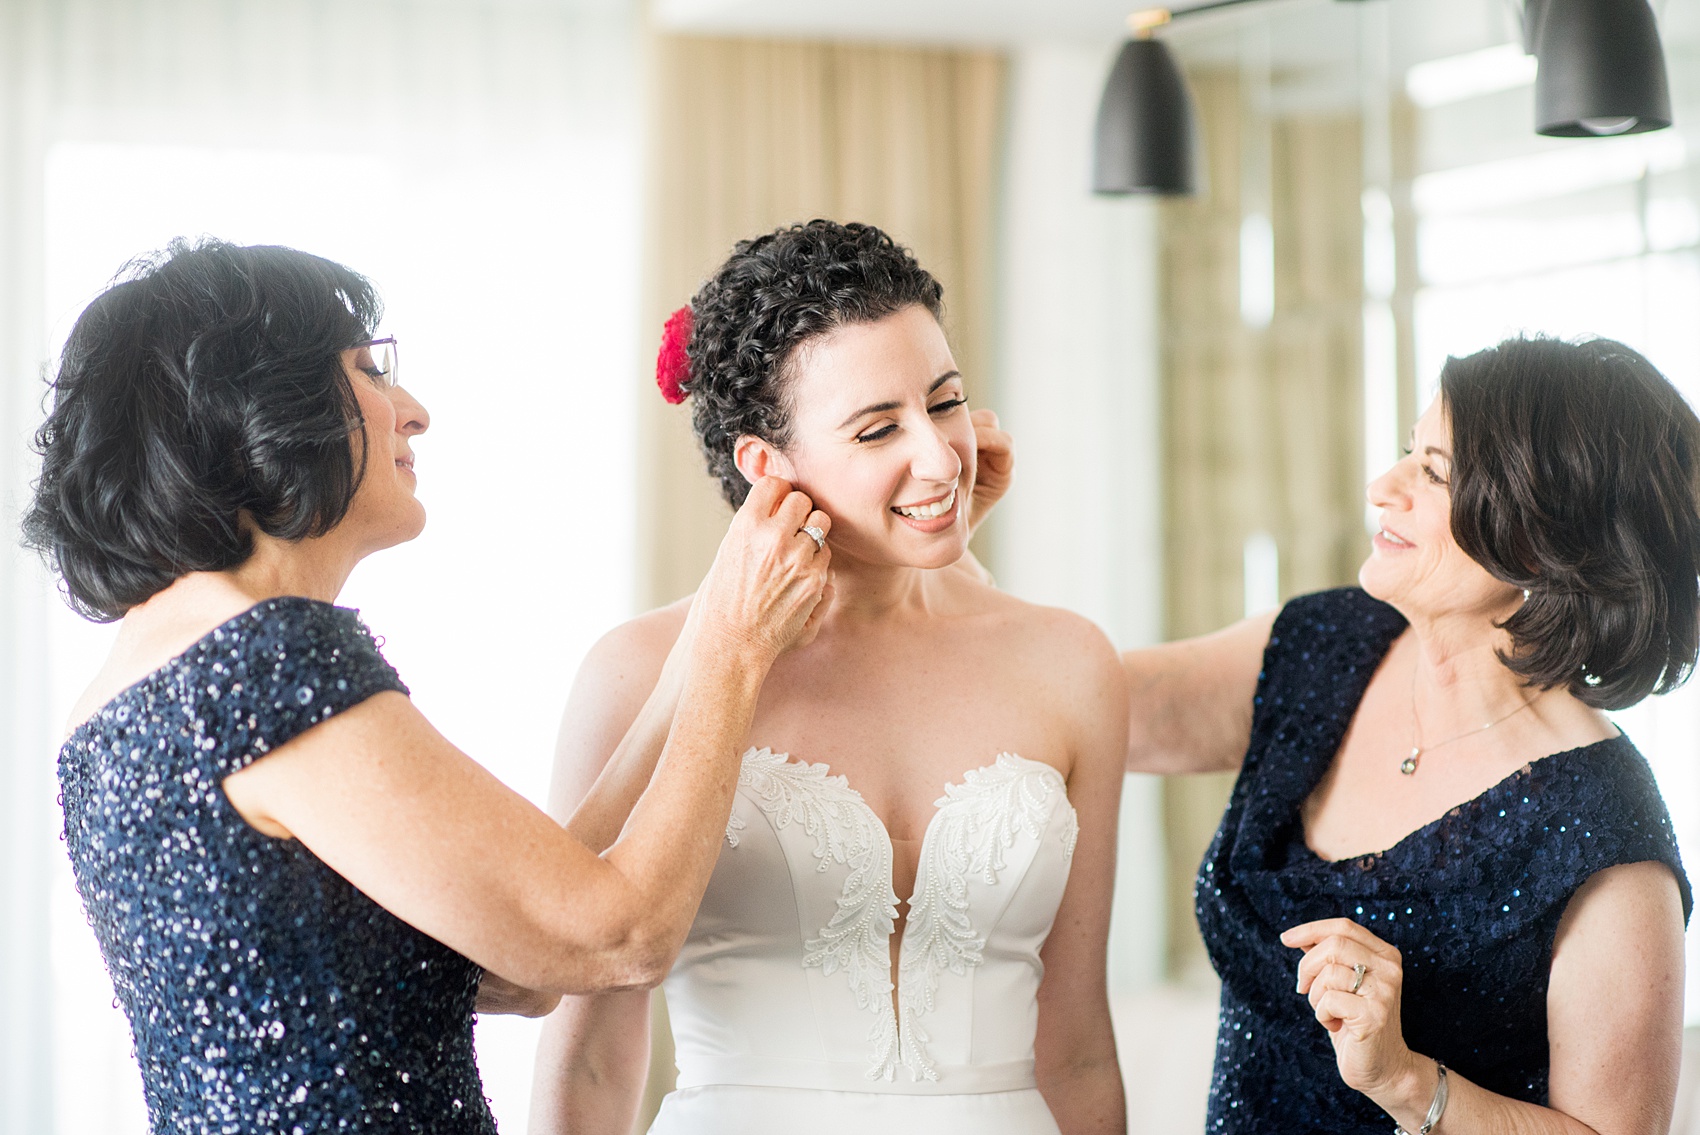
[60,598,495,1135]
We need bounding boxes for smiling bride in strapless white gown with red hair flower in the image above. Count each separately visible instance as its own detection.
[532,221,1127,1135]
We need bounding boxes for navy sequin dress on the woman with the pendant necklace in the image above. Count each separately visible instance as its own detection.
[1197,588,1692,1133]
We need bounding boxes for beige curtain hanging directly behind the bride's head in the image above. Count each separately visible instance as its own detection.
[639,36,1003,605]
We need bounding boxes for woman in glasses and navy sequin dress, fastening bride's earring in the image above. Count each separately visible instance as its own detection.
[26,241,830,1135]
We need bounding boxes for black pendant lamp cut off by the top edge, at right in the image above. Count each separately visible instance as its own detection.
[1523,0,1671,138]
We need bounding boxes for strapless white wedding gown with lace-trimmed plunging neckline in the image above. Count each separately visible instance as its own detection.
[649,749,1078,1135]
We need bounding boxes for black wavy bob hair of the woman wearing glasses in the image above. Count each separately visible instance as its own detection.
[24,240,381,622]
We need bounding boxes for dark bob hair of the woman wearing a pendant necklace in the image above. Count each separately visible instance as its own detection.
[1440,338,1700,709]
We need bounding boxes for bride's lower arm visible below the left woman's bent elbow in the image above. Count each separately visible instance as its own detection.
[529,991,649,1135]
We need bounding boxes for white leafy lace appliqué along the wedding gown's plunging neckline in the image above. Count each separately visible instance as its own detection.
[726,748,1080,1081]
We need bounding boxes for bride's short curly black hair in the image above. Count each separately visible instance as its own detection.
[685,219,944,508]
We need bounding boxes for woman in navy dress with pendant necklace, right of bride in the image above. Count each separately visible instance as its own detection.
[1124,340,1700,1135]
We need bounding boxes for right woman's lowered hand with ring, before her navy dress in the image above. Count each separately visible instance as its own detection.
[1280,918,1428,1099]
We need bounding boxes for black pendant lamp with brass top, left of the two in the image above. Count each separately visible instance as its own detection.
[1091,12,1197,195]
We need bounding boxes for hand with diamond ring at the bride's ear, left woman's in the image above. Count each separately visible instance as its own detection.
[680,477,833,663]
